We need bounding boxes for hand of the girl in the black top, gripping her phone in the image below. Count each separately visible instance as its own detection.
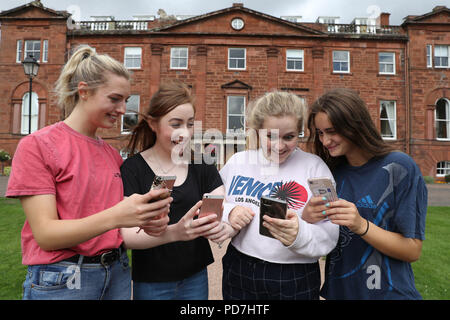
[174,201,219,241]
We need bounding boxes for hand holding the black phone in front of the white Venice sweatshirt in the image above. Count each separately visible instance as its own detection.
[263,210,299,246]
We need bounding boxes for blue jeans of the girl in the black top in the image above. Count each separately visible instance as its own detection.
[133,268,208,300]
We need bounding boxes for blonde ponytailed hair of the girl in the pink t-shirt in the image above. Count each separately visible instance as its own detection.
[55,45,131,116]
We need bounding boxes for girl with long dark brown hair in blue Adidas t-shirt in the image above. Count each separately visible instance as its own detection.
[302,89,427,299]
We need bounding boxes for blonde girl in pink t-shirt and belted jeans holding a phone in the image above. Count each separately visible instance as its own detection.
[6,46,173,299]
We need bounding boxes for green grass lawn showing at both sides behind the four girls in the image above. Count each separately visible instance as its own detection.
[0,198,450,300]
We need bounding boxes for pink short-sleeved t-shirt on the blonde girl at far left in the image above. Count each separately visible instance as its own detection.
[6,122,123,265]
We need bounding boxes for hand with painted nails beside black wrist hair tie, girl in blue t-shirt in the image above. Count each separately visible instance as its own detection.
[325,199,367,234]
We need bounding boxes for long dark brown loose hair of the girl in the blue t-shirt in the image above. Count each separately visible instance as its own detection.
[308,88,394,169]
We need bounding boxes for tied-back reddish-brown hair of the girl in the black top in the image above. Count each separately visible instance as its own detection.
[127,80,195,156]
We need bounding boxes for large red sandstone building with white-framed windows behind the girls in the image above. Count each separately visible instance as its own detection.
[0,1,450,177]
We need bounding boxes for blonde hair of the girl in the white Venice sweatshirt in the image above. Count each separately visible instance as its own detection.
[246,91,307,149]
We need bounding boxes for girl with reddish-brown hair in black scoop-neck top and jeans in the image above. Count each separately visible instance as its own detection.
[121,80,224,300]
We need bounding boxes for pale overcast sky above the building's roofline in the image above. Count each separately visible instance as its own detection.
[0,0,450,25]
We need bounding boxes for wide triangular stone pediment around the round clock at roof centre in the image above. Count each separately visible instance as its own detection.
[154,5,324,36]
